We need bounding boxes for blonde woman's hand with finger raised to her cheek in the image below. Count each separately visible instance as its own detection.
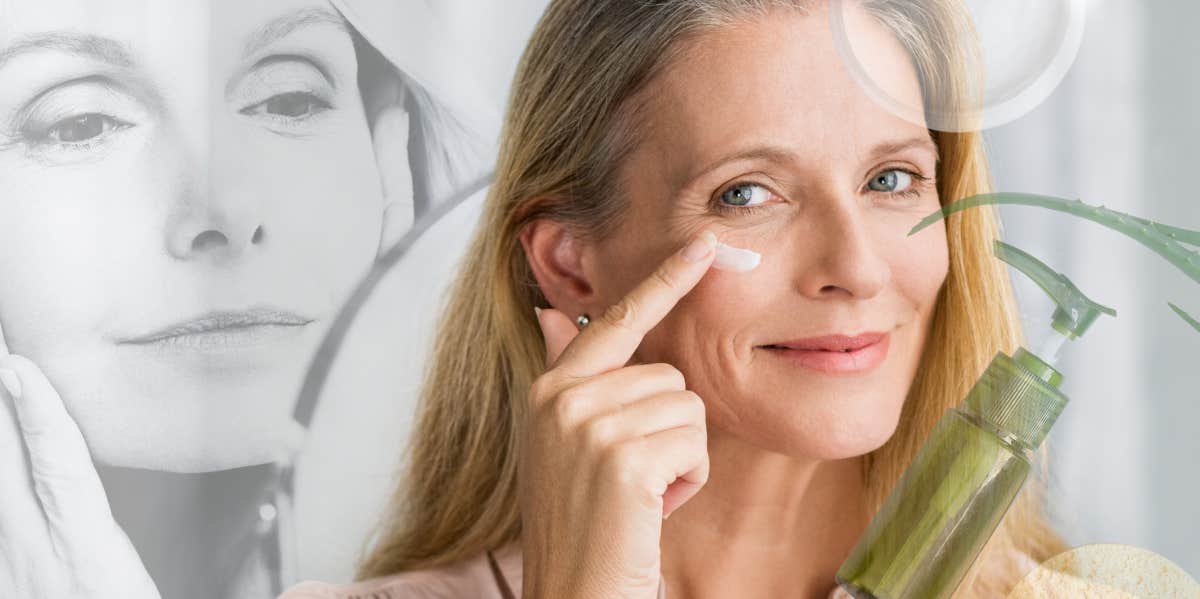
[518,232,716,599]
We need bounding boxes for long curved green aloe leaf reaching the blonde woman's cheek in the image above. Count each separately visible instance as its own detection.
[908,192,1200,283]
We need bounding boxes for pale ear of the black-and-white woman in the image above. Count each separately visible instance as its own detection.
[372,103,415,254]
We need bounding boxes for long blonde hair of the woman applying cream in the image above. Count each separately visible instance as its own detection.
[358,0,1063,597]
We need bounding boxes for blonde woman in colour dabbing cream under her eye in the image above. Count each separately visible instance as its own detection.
[286,0,1060,599]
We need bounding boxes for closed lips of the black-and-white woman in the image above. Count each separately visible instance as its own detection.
[118,307,313,349]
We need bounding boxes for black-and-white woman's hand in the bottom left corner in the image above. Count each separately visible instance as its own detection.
[0,331,158,599]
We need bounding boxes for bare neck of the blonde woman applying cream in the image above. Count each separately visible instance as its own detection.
[662,427,868,599]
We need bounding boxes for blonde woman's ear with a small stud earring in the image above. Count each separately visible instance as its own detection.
[521,218,598,317]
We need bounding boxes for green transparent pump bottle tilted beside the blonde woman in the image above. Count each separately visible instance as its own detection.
[836,240,1116,599]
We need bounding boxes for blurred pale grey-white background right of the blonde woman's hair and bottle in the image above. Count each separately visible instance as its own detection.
[986,0,1200,576]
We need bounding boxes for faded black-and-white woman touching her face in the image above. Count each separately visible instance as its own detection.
[0,0,487,598]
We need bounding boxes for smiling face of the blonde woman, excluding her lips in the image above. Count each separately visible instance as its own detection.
[592,4,948,459]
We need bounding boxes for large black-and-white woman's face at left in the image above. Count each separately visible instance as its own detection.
[0,0,383,471]
